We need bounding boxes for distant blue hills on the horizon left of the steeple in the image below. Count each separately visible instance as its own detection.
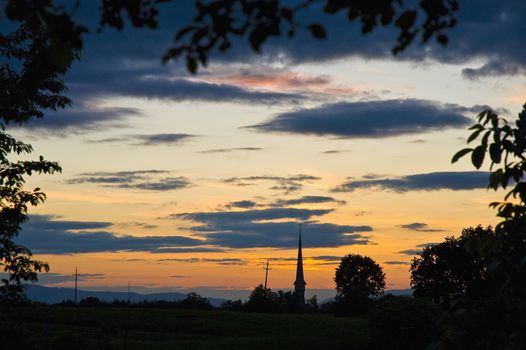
[26,285,224,306]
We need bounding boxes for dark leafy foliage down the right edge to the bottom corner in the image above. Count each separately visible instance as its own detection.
[443,104,526,349]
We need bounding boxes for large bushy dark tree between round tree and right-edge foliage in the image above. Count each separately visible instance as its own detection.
[410,226,494,303]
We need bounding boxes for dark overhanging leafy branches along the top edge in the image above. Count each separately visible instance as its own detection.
[100,0,459,73]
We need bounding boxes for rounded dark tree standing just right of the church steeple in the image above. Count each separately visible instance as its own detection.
[334,254,385,301]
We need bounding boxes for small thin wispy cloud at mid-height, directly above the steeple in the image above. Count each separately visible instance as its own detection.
[222,174,321,194]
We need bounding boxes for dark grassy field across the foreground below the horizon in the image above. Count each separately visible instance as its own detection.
[4,306,367,350]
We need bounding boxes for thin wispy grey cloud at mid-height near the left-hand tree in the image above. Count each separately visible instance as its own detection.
[67,170,193,191]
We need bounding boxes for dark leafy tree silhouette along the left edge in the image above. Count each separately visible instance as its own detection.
[0,1,85,304]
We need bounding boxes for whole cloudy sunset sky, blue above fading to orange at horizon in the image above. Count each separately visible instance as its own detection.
[11,0,526,297]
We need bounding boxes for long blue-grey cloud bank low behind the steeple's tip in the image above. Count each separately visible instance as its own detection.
[17,208,372,253]
